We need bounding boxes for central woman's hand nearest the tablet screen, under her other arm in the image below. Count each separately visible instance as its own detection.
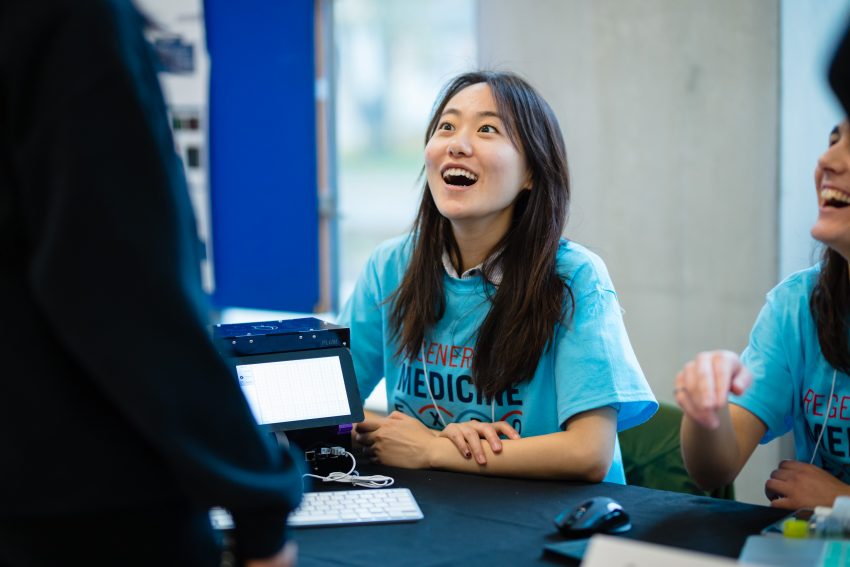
[355,411,437,469]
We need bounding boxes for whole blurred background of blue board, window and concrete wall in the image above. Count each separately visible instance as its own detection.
[140,0,850,504]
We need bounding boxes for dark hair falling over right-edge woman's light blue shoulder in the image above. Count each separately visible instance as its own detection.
[809,250,850,374]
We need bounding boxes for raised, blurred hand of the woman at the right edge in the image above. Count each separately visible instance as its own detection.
[673,350,753,429]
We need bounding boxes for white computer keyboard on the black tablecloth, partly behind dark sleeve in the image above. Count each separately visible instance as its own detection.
[210,488,424,530]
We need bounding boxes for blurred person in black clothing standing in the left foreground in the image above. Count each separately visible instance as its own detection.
[0,0,301,566]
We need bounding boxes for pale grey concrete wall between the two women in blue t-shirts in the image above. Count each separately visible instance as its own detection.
[478,0,780,503]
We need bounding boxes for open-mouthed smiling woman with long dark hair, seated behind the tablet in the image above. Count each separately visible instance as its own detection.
[341,72,657,483]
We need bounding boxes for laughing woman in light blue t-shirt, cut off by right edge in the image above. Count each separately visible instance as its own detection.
[675,120,850,509]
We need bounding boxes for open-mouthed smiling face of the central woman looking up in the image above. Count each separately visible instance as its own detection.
[425,83,531,233]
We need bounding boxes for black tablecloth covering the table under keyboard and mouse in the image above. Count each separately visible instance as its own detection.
[295,465,787,567]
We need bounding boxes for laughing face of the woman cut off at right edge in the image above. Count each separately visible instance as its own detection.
[812,120,850,259]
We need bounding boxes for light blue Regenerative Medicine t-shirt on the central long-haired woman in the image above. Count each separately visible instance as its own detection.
[340,236,658,484]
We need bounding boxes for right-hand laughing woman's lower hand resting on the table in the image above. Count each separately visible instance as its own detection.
[764,461,850,510]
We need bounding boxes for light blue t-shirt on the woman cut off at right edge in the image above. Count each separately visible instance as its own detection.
[731,266,850,482]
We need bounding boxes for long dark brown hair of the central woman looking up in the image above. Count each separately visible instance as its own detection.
[390,71,573,398]
